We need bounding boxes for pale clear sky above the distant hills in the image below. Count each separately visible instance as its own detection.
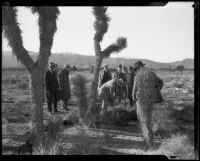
[2,2,194,62]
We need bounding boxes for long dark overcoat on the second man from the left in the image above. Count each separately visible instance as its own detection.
[58,69,71,100]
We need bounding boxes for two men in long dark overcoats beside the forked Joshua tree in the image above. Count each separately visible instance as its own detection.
[44,62,71,114]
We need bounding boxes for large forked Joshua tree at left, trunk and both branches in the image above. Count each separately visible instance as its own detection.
[2,6,59,136]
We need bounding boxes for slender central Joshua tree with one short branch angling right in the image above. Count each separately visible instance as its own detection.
[87,7,127,127]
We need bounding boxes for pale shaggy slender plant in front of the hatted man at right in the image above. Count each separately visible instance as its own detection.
[134,67,162,147]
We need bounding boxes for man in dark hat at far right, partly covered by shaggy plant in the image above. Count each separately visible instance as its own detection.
[132,61,163,147]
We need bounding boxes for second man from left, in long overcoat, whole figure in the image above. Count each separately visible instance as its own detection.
[58,64,71,110]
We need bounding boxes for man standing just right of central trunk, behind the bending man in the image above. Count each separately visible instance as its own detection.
[98,64,112,88]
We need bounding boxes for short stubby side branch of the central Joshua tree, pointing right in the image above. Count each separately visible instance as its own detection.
[102,37,127,58]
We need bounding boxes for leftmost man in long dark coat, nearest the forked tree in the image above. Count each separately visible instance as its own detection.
[45,62,58,113]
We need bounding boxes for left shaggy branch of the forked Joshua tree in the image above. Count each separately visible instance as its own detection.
[2,6,34,72]
